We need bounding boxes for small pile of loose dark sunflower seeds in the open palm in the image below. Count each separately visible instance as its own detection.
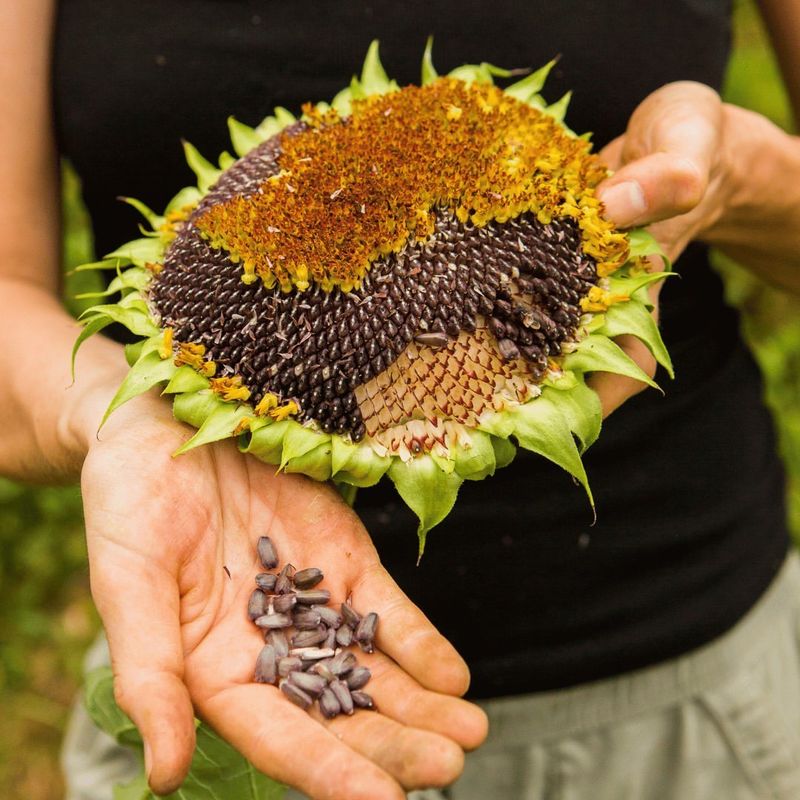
[247,536,378,719]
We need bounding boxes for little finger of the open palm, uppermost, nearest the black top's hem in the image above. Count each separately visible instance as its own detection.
[353,563,470,696]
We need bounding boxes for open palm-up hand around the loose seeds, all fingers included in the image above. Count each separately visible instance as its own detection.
[82,396,487,800]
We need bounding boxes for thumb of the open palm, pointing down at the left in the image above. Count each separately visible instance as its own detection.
[87,536,195,794]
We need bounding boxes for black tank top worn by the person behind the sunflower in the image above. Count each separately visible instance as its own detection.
[54,0,788,697]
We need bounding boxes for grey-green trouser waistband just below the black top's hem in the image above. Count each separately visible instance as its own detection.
[480,548,800,749]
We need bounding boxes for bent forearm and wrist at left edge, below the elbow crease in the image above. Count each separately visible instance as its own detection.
[0,278,125,482]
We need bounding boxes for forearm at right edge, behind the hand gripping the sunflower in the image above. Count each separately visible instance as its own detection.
[701,105,800,293]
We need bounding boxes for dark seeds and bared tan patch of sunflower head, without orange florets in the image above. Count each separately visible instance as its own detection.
[149,131,597,441]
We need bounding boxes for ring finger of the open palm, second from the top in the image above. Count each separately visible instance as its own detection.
[360,652,489,750]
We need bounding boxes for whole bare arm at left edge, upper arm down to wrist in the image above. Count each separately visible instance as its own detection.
[0,0,124,480]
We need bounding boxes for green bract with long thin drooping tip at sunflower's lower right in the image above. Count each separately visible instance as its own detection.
[506,394,594,508]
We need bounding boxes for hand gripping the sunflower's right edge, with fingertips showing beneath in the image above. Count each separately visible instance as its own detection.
[588,81,729,416]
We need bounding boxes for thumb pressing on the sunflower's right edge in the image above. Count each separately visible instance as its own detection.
[597,81,722,228]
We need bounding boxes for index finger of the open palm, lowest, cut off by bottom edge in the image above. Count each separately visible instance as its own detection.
[199,684,406,800]
